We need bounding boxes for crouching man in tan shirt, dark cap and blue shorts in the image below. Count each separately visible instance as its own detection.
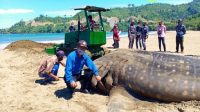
[38,50,65,84]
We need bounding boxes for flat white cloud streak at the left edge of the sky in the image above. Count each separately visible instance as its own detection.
[0,9,34,15]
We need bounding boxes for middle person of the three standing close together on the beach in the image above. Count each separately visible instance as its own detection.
[136,21,142,49]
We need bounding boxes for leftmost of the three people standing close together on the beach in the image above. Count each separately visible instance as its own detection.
[128,20,136,49]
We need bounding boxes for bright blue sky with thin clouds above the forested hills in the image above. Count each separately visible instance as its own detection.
[0,0,192,29]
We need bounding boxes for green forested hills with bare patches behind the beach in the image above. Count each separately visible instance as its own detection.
[0,0,200,33]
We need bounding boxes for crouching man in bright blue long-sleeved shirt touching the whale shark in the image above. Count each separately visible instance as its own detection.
[64,40,101,93]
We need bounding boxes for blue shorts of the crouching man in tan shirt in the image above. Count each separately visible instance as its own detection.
[41,63,60,81]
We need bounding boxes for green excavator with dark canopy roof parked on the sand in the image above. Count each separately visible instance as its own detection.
[45,6,109,59]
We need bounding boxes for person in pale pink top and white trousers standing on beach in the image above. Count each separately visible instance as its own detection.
[157,21,166,51]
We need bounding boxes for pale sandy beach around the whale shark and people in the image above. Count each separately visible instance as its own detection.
[0,31,200,112]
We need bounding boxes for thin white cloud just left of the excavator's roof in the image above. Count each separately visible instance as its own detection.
[45,10,79,17]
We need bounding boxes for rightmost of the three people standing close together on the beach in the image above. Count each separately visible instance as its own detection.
[142,22,149,50]
